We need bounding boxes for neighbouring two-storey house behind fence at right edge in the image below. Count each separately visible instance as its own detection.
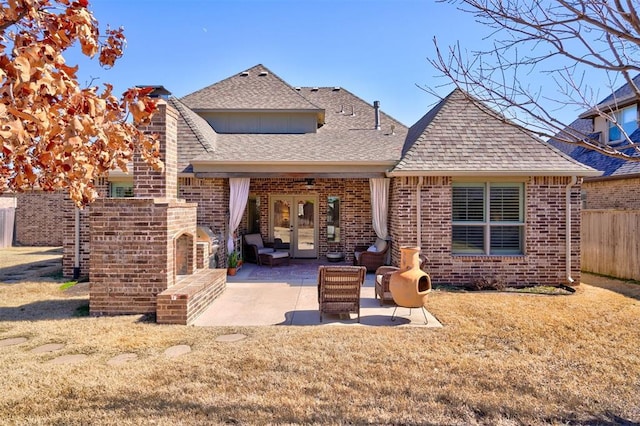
[549,74,640,209]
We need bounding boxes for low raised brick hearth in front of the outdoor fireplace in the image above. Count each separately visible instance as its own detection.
[156,269,227,325]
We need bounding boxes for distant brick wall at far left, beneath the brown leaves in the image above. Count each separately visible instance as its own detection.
[11,190,67,247]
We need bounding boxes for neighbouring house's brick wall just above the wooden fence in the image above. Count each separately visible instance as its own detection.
[582,176,640,210]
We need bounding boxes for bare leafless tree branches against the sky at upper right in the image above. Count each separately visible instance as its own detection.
[430,0,640,161]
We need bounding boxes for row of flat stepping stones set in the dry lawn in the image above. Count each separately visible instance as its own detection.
[0,334,247,366]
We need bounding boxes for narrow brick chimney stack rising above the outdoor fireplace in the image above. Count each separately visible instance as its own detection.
[133,99,178,199]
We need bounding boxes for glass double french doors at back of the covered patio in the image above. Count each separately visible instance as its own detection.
[269,194,318,258]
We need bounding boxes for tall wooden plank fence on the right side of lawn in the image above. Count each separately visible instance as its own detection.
[580,210,640,281]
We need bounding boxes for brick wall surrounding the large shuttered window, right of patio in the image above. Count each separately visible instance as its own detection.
[389,177,580,286]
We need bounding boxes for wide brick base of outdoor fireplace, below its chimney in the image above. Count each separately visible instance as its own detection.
[89,198,196,315]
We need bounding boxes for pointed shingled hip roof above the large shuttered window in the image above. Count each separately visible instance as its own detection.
[391,89,600,176]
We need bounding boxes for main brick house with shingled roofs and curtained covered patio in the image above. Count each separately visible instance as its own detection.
[58,65,600,318]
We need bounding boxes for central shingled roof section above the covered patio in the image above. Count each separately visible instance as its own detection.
[175,65,407,173]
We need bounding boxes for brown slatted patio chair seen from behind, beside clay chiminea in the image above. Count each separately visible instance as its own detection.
[318,265,367,322]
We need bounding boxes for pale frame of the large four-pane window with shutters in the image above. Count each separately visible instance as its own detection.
[451,181,526,256]
